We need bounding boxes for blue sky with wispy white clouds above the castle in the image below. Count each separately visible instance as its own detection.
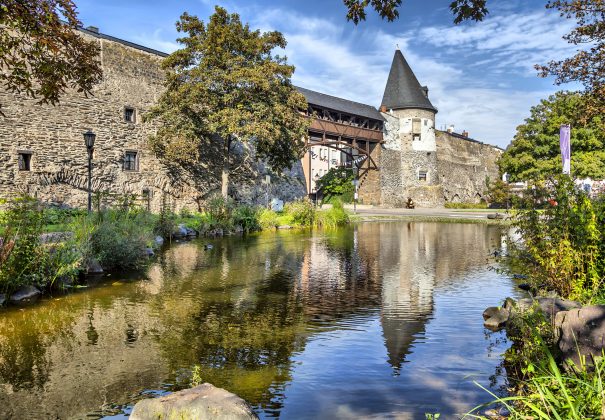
[76,0,574,147]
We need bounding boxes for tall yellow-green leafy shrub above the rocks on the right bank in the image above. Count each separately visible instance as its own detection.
[515,176,605,302]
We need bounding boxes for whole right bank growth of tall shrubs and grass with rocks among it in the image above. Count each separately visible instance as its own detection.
[475,176,605,419]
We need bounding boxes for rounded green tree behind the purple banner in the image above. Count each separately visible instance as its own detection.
[499,92,605,181]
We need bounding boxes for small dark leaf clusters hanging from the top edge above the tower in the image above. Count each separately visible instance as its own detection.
[343,0,488,25]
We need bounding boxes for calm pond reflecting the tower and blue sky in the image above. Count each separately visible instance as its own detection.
[0,222,516,419]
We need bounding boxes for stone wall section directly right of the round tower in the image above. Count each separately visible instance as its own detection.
[437,131,503,203]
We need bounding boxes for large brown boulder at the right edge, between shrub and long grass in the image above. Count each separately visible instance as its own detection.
[555,305,605,366]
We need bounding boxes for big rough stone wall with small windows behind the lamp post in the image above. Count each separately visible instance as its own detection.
[0,33,305,211]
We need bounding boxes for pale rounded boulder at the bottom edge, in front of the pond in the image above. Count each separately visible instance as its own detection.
[130,384,258,420]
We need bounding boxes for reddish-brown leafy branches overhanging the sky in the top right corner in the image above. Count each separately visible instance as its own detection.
[536,0,605,118]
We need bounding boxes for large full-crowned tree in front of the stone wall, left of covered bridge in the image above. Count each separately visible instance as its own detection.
[147,6,308,197]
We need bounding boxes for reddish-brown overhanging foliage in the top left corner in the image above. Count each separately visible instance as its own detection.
[0,0,102,115]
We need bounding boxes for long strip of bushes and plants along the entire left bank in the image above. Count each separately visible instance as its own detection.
[0,196,349,306]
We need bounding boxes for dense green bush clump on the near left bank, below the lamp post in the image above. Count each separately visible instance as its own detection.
[0,197,158,303]
